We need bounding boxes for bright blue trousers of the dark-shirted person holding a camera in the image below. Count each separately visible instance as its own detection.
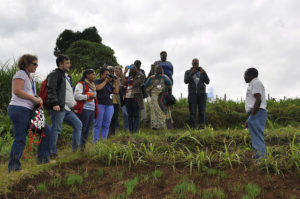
[93,104,114,142]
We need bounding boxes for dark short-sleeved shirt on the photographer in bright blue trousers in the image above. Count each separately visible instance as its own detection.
[95,79,114,105]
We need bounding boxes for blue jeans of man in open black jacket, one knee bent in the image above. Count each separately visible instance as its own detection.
[50,110,82,155]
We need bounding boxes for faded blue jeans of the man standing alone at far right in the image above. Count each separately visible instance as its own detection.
[247,109,267,159]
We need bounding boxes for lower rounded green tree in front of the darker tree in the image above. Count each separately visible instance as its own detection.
[65,40,118,71]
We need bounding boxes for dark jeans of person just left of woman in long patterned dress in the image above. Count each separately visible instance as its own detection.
[125,98,140,133]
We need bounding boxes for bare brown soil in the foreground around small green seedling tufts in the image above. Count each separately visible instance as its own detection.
[0,159,300,199]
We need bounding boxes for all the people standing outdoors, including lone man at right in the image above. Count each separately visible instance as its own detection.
[8,51,266,172]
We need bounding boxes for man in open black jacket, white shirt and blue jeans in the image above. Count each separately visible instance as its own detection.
[47,55,82,158]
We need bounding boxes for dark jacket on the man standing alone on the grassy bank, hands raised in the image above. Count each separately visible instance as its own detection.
[184,68,209,95]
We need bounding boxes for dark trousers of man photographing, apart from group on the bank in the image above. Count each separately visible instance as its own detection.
[188,93,207,128]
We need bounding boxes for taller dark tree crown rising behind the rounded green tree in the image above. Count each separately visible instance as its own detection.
[54,27,102,57]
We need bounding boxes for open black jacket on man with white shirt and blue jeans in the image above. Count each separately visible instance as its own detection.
[47,68,66,110]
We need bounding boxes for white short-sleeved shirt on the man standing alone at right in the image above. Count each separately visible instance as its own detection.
[245,78,267,113]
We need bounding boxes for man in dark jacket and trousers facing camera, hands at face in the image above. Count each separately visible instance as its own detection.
[184,58,209,129]
